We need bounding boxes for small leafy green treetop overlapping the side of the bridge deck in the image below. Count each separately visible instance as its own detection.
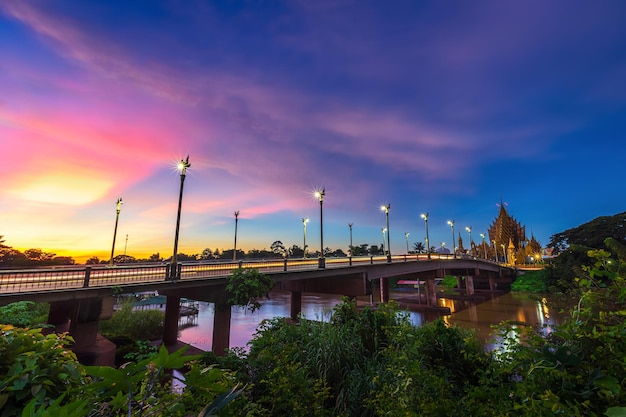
[226,268,274,311]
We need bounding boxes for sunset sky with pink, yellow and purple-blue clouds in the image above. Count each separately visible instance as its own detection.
[0,0,626,261]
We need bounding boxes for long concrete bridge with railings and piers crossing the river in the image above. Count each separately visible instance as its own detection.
[0,254,516,365]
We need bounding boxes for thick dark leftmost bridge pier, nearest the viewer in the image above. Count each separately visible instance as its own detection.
[48,297,116,366]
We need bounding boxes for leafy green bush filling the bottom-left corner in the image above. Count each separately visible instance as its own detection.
[0,325,84,417]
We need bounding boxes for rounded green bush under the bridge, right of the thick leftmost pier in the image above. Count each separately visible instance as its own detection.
[100,303,165,340]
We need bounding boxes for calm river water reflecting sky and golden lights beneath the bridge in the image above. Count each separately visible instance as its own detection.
[179,291,559,351]
